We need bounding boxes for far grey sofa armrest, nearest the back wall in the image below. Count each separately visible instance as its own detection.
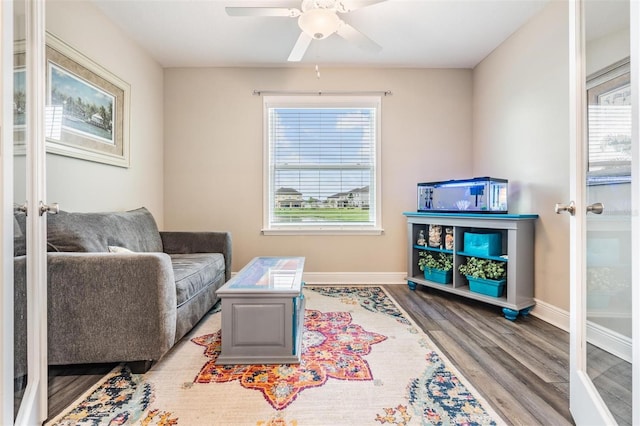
[160,231,232,281]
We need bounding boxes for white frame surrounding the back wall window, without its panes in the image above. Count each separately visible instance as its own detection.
[262,95,383,235]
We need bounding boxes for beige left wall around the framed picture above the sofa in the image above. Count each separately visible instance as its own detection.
[40,0,164,225]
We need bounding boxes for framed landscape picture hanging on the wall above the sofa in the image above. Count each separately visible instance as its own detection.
[46,34,131,167]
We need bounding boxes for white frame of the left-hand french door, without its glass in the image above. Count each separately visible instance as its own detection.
[0,0,47,425]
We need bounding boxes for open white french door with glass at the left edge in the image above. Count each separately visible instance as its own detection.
[0,0,47,425]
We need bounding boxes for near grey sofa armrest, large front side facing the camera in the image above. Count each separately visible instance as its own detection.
[47,252,176,364]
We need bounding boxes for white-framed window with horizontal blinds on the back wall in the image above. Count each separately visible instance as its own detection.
[263,96,381,234]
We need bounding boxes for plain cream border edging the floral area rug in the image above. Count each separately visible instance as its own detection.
[44,284,507,426]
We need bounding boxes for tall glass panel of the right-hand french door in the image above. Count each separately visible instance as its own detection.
[578,0,637,424]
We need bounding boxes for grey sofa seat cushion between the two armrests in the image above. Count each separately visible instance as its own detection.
[169,253,225,307]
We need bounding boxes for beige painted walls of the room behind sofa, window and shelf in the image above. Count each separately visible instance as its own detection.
[47,0,569,309]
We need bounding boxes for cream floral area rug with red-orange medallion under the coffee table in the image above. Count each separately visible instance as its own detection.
[48,286,503,426]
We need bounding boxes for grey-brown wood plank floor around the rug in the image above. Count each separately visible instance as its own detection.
[43,285,631,425]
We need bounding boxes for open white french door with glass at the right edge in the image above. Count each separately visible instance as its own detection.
[568,0,640,425]
